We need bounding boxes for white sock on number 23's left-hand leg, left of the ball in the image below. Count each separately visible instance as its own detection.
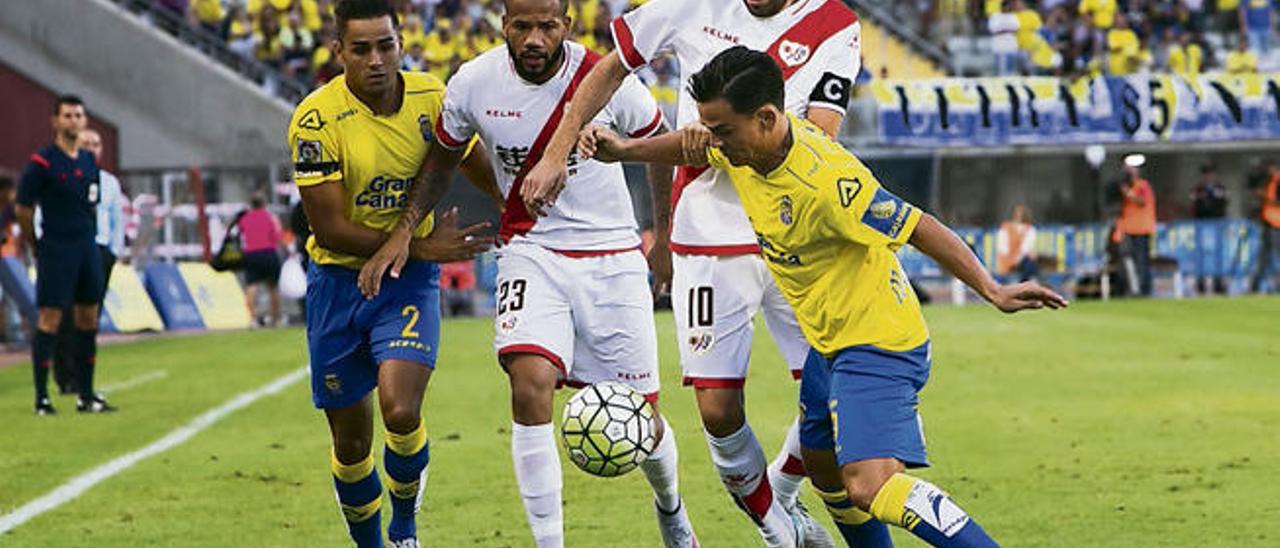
[511,423,564,548]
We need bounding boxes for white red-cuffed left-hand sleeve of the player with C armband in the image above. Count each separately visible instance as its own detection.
[611,0,691,70]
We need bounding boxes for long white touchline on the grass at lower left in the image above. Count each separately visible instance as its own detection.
[0,367,307,535]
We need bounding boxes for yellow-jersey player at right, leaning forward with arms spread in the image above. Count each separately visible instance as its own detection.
[580,46,1068,547]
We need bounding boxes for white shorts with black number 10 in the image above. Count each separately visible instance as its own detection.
[671,254,809,388]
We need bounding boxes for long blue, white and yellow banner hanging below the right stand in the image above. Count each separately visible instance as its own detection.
[870,73,1280,147]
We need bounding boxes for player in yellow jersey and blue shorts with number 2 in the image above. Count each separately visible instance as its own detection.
[288,0,497,548]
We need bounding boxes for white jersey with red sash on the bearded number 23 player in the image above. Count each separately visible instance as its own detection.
[435,42,662,251]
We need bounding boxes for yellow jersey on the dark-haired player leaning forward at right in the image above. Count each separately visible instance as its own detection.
[708,113,929,356]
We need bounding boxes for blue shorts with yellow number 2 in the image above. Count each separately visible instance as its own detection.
[306,261,440,408]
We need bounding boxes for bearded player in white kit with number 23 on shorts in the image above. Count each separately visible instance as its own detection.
[366,0,696,548]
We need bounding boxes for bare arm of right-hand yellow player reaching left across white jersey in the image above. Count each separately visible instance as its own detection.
[577,124,710,165]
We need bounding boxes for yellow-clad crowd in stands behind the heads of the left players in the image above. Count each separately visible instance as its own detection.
[160,0,660,92]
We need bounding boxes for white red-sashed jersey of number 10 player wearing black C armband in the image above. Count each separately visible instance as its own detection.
[613,0,861,255]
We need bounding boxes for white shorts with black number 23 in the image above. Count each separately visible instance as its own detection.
[483,242,659,401]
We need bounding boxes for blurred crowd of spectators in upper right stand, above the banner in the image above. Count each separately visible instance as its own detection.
[914,0,1276,78]
